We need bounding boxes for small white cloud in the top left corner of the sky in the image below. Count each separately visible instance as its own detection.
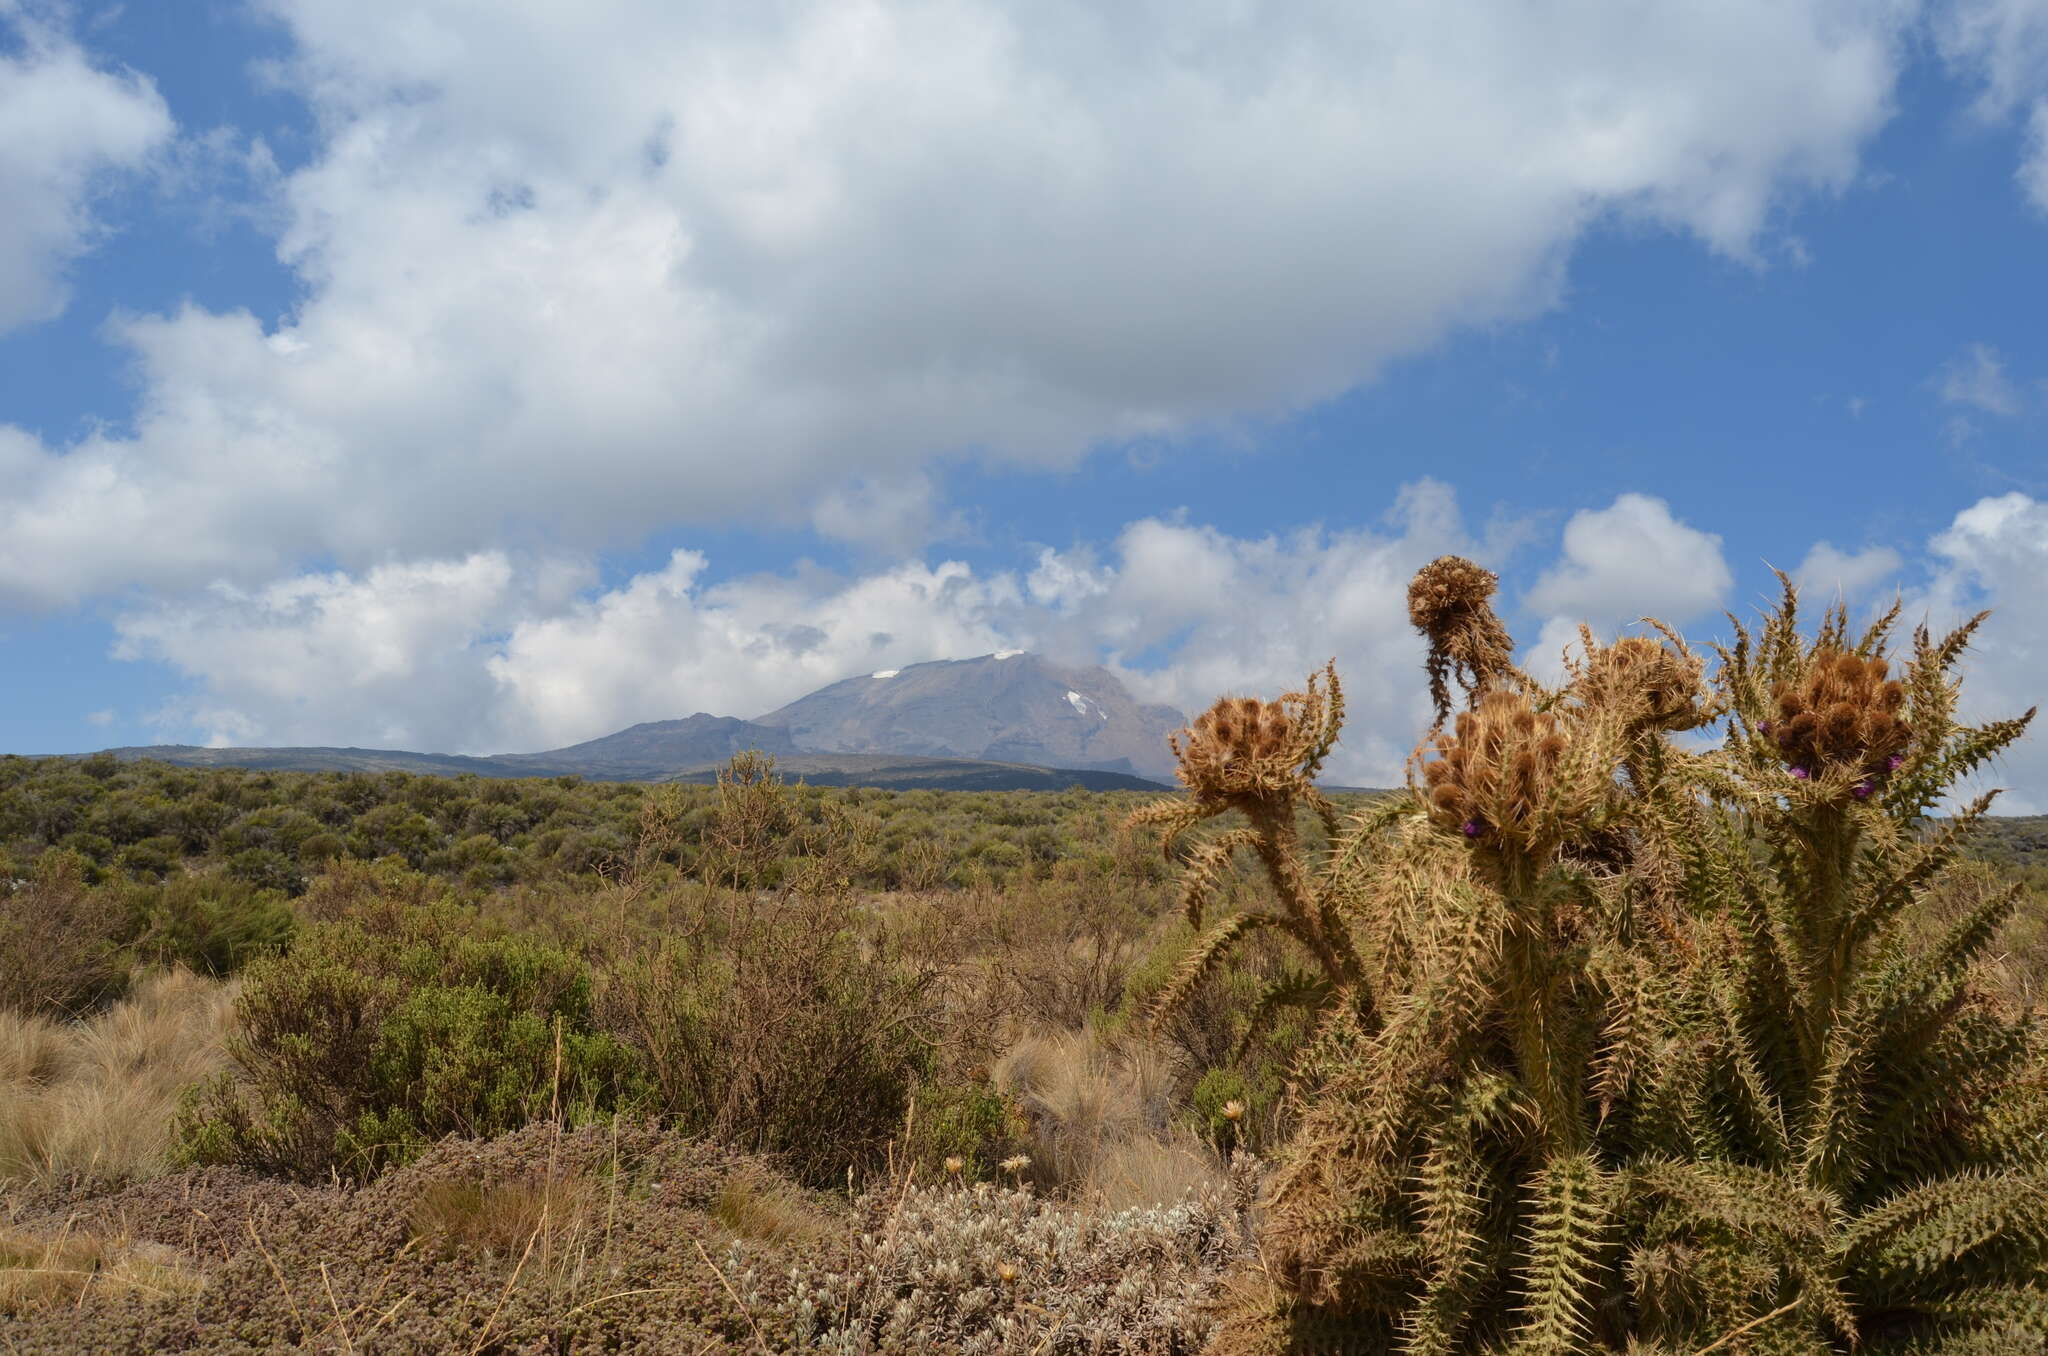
[0,0,172,334]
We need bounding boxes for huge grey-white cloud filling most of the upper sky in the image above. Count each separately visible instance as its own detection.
[0,0,1911,606]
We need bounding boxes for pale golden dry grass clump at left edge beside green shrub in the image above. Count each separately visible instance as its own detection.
[0,971,233,1184]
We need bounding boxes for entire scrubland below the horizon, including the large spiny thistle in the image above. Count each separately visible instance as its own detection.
[0,559,2048,1356]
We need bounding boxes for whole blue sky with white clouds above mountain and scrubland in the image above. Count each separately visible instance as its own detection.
[0,0,2048,809]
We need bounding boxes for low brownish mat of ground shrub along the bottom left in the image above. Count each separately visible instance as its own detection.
[0,1125,807,1356]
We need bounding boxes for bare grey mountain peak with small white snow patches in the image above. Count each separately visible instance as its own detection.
[754,649,1188,780]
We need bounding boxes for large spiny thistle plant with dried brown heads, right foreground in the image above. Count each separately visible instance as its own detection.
[1149,561,2048,1356]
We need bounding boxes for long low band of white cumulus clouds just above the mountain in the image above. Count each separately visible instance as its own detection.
[117,481,1511,782]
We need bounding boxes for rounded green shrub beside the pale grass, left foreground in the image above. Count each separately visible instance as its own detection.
[180,899,643,1178]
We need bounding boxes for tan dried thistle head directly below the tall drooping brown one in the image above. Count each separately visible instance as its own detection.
[1421,690,1571,852]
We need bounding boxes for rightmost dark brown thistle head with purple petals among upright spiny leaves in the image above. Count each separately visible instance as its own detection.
[1763,649,1913,797]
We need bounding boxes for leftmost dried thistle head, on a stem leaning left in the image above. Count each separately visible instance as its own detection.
[1171,666,1343,809]
